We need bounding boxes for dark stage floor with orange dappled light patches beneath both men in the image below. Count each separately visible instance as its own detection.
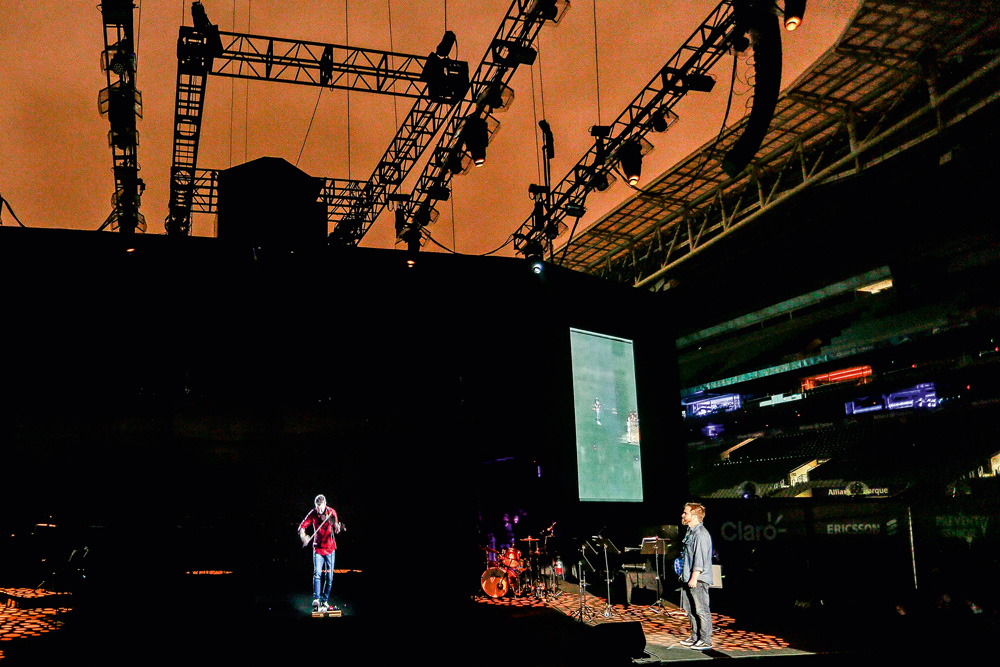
[0,573,997,666]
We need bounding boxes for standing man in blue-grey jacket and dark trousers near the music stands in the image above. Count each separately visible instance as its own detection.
[680,503,713,651]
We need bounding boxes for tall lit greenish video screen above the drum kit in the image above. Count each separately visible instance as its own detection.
[570,328,642,502]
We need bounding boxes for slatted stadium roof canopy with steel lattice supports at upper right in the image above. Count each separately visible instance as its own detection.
[560,0,1000,289]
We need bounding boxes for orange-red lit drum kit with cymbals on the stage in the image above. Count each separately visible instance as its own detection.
[479,537,562,598]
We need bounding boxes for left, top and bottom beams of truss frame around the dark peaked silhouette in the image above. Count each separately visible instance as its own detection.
[165,2,468,236]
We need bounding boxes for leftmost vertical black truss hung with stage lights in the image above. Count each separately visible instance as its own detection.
[97,0,146,234]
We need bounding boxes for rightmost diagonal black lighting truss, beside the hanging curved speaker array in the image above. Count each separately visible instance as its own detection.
[514,0,740,254]
